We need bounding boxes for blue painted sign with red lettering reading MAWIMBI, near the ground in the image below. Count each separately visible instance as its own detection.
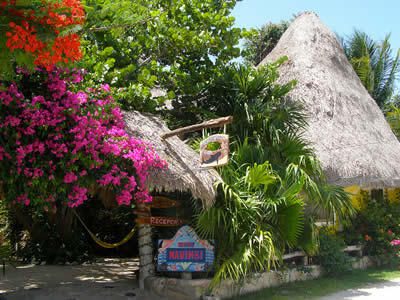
[157,226,214,272]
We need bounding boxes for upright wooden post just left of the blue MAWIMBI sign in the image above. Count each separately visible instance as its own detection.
[137,224,154,290]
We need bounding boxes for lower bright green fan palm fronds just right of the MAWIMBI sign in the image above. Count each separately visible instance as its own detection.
[197,162,304,288]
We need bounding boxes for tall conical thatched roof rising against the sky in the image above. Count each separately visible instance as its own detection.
[260,12,400,187]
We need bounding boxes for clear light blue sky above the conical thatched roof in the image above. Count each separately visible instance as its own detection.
[232,0,400,55]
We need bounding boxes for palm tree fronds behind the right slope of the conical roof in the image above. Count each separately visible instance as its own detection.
[341,30,400,108]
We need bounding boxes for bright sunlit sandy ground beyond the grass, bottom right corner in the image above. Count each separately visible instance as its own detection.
[318,278,400,300]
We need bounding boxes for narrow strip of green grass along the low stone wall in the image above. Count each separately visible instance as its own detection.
[233,269,400,300]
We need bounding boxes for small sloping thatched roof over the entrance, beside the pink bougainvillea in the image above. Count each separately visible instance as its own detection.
[124,111,220,207]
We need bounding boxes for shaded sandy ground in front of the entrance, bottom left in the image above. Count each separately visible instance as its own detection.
[0,259,159,300]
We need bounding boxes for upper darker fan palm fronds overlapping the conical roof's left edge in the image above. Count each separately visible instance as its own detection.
[199,58,354,219]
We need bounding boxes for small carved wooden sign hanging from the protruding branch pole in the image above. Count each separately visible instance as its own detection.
[200,134,229,167]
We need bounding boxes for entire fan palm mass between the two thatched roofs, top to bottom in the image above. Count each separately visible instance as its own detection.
[198,58,354,287]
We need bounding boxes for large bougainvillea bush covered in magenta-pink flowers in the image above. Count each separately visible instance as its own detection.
[0,68,166,211]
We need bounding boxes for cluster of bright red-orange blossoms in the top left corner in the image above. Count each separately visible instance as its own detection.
[0,0,85,70]
